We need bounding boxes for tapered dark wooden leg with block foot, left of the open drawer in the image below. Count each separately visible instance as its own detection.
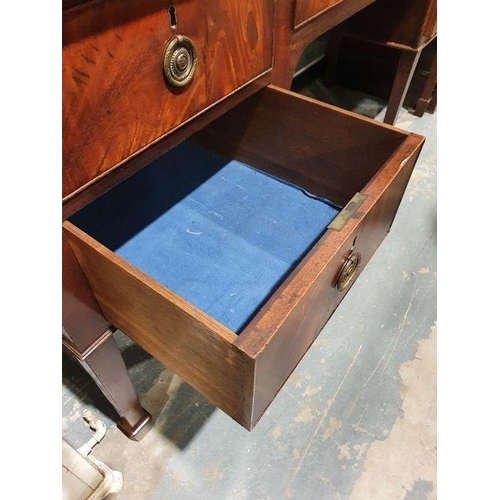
[62,232,152,440]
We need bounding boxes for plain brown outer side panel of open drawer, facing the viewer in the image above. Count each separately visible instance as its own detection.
[63,221,245,425]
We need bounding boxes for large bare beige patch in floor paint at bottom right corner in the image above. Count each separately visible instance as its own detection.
[351,327,437,500]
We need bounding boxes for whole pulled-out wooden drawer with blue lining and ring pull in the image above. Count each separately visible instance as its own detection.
[63,86,424,430]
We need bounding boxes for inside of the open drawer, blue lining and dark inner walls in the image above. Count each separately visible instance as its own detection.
[70,87,406,334]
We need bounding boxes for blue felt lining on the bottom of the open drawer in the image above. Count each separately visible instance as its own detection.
[71,141,340,333]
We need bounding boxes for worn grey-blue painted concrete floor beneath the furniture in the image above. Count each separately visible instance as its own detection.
[62,80,437,500]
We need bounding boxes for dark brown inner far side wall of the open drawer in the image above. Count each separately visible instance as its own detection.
[194,85,408,207]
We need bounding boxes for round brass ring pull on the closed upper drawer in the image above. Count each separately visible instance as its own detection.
[163,35,198,87]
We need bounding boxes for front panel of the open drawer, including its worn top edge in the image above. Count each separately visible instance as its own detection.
[235,135,423,427]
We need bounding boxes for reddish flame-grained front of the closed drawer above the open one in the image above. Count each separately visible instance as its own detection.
[63,0,274,198]
